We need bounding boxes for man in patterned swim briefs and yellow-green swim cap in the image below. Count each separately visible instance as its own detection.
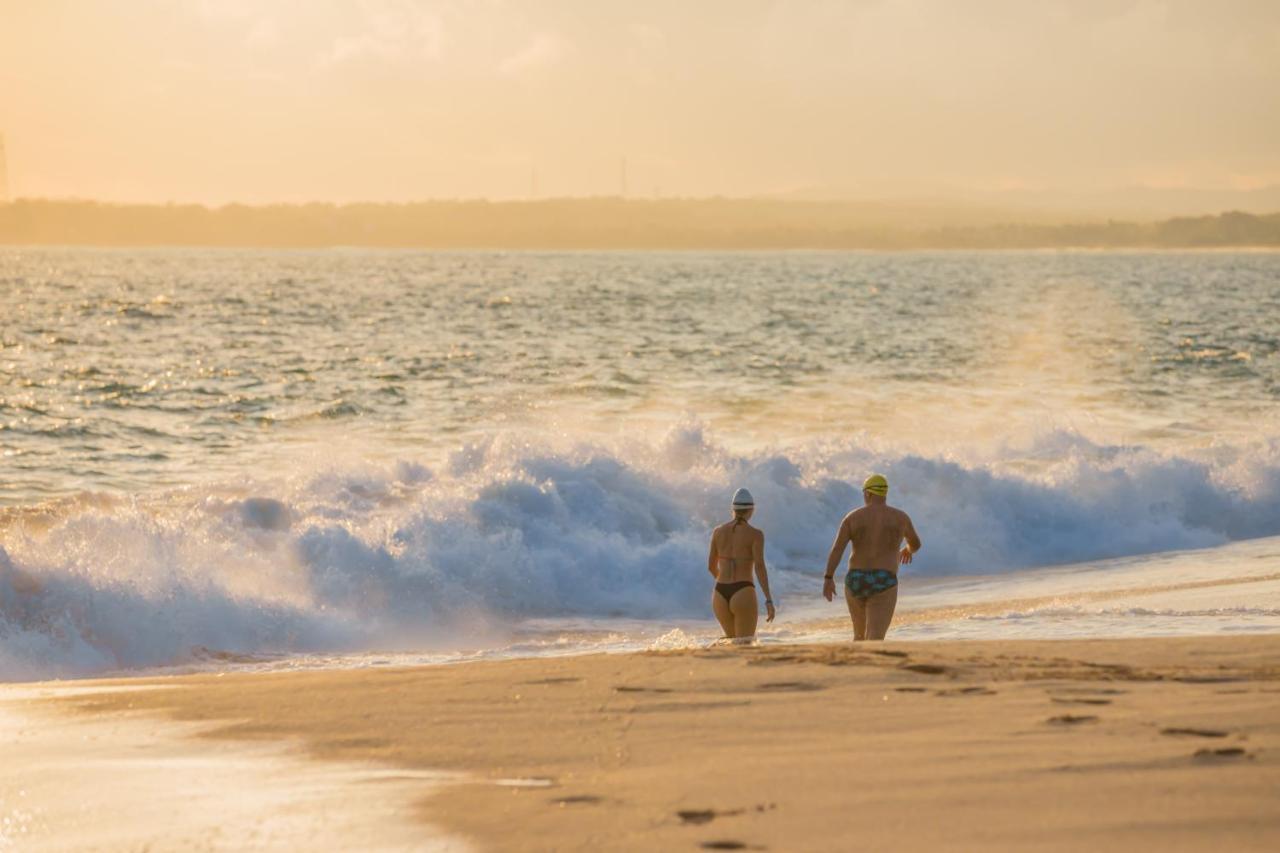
[822,474,920,640]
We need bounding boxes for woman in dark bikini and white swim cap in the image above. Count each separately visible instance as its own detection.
[707,489,774,639]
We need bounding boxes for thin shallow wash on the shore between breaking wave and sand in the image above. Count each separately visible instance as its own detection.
[0,537,1280,686]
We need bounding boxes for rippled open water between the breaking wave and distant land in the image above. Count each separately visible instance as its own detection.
[0,250,1280,503]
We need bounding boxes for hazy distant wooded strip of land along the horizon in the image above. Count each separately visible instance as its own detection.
[0,199,1280,248]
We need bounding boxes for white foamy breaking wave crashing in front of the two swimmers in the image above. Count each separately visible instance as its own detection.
[0,424,1280,680]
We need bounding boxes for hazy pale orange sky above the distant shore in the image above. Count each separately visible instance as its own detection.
[0,0,1280,204]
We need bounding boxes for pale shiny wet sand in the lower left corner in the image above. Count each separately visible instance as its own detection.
[0,683,471,853]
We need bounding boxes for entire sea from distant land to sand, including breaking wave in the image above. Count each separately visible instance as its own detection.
[0,248,1280,680]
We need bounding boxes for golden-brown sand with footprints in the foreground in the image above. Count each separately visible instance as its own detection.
[6,635,1280,850]
